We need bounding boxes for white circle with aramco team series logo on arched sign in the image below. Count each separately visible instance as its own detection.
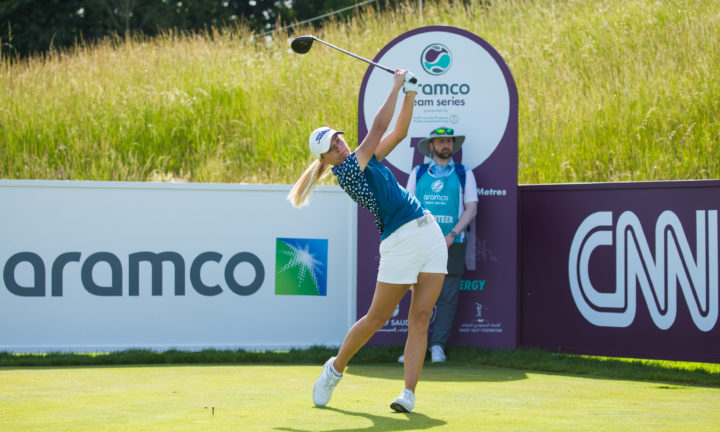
[361,27,510,173]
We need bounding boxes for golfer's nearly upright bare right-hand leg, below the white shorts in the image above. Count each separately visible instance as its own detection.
[404,273,445,392]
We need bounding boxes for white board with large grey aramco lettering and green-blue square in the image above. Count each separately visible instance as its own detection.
[0,180,357,352]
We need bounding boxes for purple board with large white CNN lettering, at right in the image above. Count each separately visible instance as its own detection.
[520,181,720,362]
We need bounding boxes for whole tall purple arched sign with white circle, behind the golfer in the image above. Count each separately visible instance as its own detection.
[357,26,518,348]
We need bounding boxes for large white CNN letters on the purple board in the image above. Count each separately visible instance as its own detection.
[568,210,718,332]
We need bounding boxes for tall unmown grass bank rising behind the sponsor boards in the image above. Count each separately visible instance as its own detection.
[0,0,720,184]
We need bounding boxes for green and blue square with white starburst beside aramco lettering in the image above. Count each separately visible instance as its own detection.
[275,238,328,296]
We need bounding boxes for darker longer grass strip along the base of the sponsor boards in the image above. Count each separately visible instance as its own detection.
[0,346,720,387]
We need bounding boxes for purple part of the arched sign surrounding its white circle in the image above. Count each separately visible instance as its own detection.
[357,26,518,348]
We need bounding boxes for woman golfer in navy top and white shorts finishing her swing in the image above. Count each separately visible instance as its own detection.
[288,70,447,412]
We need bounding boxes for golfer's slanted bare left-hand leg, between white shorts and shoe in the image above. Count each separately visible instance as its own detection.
[333,281,410,373]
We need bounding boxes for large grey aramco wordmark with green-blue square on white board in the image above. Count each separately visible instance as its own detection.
[0,238,328,297]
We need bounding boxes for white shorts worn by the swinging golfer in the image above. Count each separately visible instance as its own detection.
[378,213,447,284]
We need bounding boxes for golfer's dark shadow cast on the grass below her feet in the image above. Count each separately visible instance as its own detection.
[275,407,447,432]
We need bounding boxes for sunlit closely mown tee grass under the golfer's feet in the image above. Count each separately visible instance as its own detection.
[0,362,720,432]
